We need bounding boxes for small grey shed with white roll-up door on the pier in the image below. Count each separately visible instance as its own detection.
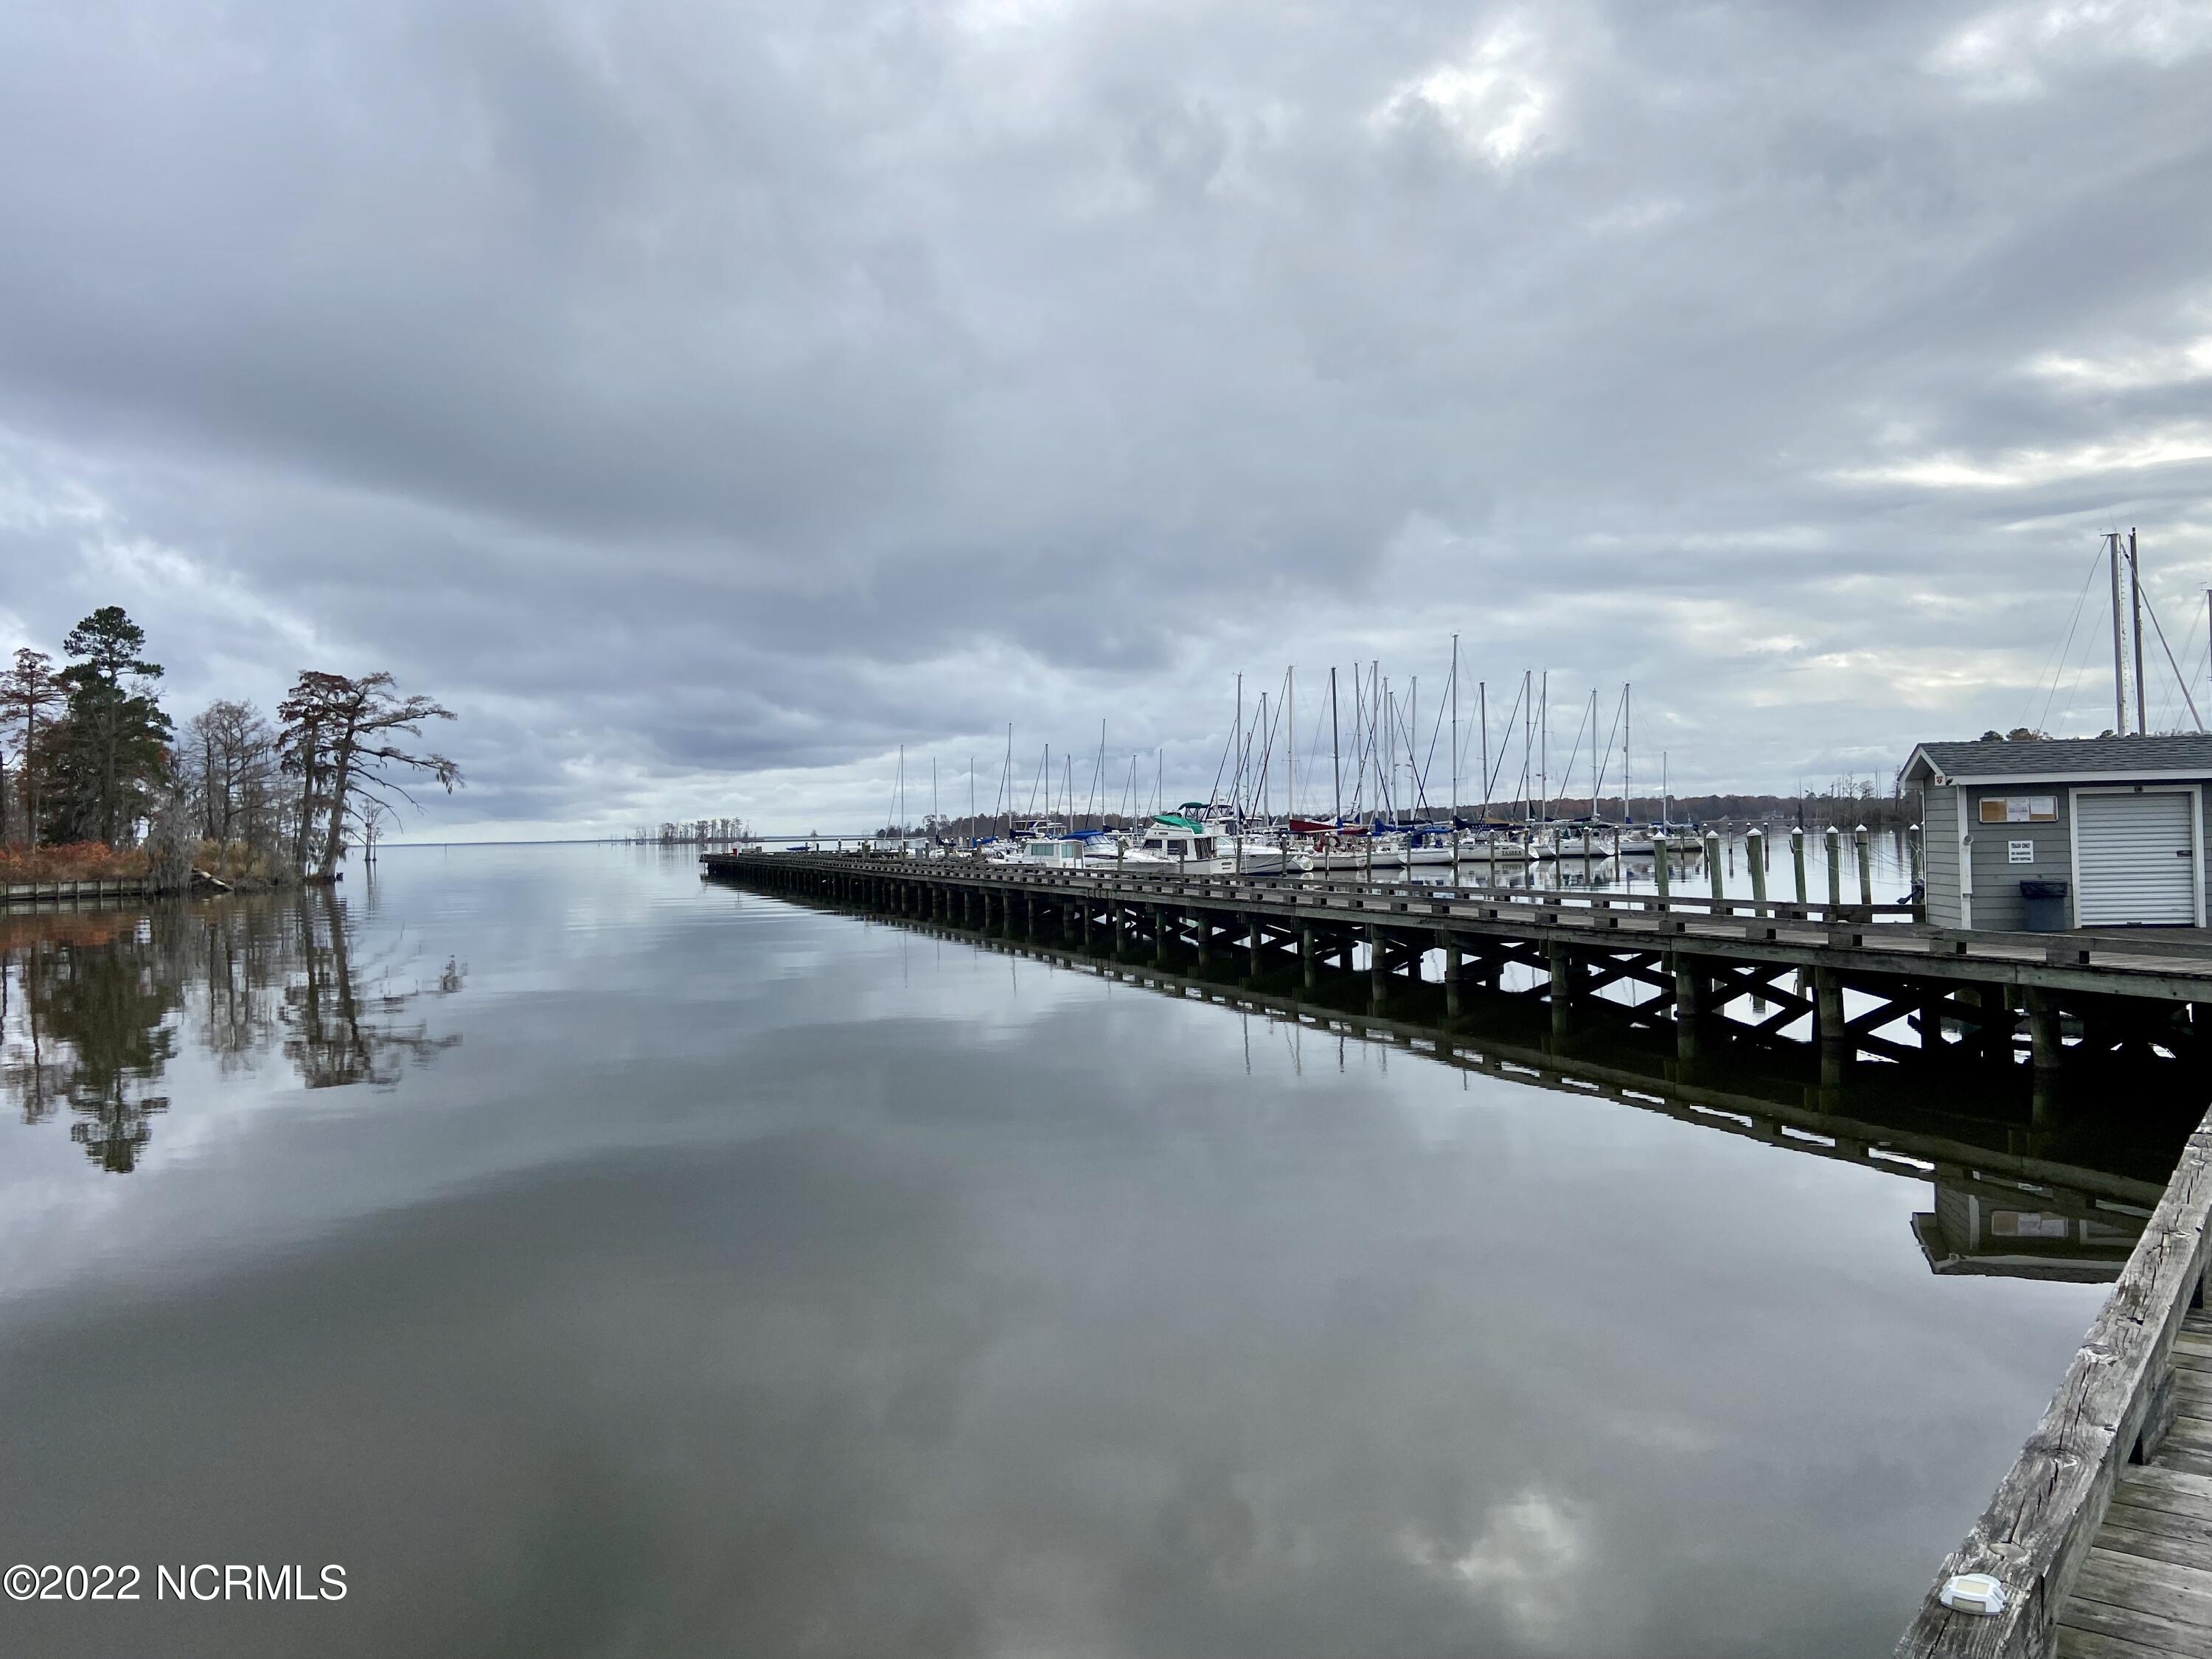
[1902,734,2212,931]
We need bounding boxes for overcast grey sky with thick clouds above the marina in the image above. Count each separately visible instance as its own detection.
[0,0,2212,836]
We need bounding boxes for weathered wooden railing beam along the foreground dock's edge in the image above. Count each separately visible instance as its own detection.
[1896,1113,2212,1659]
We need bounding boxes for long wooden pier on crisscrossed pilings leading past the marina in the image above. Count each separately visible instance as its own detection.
[701,852,2212,1102]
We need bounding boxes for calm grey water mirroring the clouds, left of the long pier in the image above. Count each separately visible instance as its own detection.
[0,847,2101,1659]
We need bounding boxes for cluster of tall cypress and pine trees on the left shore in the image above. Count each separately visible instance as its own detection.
[0,604,460,887]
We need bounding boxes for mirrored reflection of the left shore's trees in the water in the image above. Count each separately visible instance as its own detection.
[0,891,467,1175]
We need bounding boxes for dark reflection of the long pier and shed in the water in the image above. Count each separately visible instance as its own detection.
[708,876,2174,1279]
